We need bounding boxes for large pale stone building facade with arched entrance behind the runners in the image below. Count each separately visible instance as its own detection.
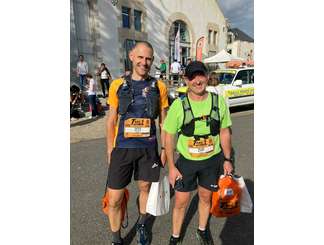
[70,0,227,82]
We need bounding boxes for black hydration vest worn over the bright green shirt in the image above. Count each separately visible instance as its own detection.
[180,93,220,138]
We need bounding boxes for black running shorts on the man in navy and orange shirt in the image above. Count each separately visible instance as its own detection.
[108,148,161,189]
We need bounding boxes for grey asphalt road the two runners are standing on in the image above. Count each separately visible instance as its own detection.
[71,110,254,245]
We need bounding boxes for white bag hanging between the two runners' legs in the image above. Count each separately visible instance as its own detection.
[146,173,170,216]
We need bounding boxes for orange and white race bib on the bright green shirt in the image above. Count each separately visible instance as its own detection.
[188,137,214,157]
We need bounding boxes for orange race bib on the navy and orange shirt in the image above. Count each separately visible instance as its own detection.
[124,118,151,138]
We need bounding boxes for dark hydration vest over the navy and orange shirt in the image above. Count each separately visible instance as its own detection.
[117,75,160,119]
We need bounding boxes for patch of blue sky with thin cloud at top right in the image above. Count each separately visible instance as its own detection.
[218,0,254,38]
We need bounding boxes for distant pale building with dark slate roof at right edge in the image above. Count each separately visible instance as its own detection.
[227,28,254,60]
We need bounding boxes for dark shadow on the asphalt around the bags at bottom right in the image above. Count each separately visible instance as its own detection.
[220,179,254,245]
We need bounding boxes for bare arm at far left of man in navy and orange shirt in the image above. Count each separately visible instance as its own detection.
[106,107,118,164]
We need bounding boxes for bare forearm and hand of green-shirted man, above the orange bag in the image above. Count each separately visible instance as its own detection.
[219,128,233,174]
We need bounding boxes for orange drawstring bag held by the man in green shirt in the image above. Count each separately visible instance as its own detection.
[210,175,241,217]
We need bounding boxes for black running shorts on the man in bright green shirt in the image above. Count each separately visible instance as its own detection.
[176,153,224,192]
